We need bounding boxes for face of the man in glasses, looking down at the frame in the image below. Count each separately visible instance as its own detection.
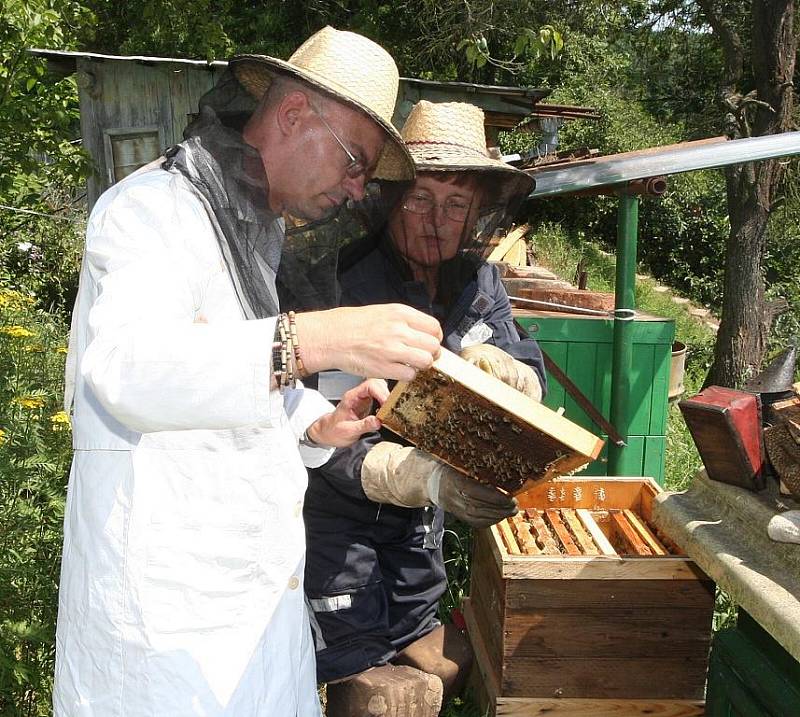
[284,102,385,221]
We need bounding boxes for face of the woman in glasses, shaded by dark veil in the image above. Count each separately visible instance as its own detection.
[389,173,481,268]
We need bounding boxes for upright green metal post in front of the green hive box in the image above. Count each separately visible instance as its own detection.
[608,194,641,476]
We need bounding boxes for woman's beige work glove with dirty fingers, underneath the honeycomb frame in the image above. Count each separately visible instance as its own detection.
[361,441,517,528]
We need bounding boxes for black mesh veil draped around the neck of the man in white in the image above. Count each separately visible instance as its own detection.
[164,70,380,319]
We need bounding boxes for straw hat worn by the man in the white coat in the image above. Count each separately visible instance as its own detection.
[230,26,414,180]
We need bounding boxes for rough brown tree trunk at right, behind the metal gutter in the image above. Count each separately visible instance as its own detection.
[702,0,797,386]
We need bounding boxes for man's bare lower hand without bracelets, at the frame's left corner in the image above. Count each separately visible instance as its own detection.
[306,378,389,448]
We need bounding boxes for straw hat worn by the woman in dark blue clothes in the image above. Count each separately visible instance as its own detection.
[400,100,536,192]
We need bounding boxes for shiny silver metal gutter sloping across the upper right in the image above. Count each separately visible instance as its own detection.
[526,132,800,197]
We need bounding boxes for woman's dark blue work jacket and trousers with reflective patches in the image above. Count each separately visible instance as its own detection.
[304,242,545,682]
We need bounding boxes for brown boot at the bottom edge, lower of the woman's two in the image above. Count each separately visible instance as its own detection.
[325,665,442,717]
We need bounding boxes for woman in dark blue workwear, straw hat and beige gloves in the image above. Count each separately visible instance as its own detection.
[305,101,545,717]
